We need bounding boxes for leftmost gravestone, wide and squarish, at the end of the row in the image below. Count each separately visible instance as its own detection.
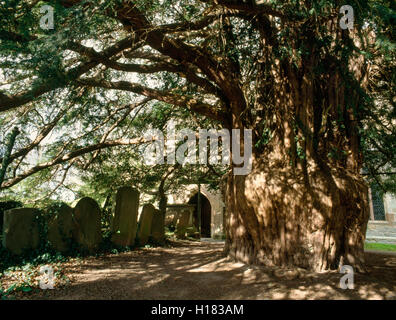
[3,208,40,254]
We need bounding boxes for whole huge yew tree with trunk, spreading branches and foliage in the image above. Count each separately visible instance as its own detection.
[0,0,396,269]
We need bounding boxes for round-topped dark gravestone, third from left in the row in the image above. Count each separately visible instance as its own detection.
[74,197,102,252]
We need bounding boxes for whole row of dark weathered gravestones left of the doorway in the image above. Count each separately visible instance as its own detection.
[0,187,165,254]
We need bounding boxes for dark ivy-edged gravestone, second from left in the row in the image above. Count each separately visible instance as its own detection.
[48,203,75,253]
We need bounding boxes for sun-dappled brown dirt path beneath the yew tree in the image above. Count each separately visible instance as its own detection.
[26,242,396,300]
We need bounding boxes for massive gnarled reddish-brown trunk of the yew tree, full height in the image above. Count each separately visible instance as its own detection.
[225,37,369,272]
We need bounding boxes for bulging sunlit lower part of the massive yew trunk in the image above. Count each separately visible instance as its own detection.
[225,153,369,271]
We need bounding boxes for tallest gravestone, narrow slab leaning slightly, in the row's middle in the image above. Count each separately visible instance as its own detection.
[111,187,139,246]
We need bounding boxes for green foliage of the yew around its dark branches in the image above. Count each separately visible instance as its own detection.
[0,0,396,198]
